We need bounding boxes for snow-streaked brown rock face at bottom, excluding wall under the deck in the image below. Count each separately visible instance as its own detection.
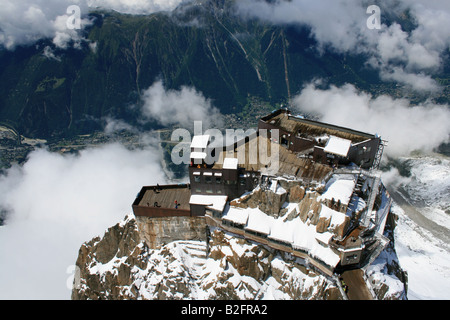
[72,216,342,299]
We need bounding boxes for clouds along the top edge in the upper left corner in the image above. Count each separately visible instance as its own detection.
[0,0,186,50]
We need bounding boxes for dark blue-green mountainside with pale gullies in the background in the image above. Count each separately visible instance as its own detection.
[0,1,446,138]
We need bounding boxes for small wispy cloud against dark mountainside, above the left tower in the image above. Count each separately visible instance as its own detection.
[142,81,222,129]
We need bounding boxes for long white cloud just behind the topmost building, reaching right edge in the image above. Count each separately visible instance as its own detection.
[293,84,450,157]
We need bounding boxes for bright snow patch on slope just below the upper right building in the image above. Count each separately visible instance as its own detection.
[319,175,356,205]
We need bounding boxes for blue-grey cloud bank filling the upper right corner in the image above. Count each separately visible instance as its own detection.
[236,0,450,91]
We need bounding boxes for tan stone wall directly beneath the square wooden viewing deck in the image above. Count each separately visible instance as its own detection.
[136,216,206,249]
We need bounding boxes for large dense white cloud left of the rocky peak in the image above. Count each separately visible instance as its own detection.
[0,144,165,299]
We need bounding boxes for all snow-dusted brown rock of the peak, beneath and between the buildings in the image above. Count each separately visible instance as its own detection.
[72,183,407,300]
